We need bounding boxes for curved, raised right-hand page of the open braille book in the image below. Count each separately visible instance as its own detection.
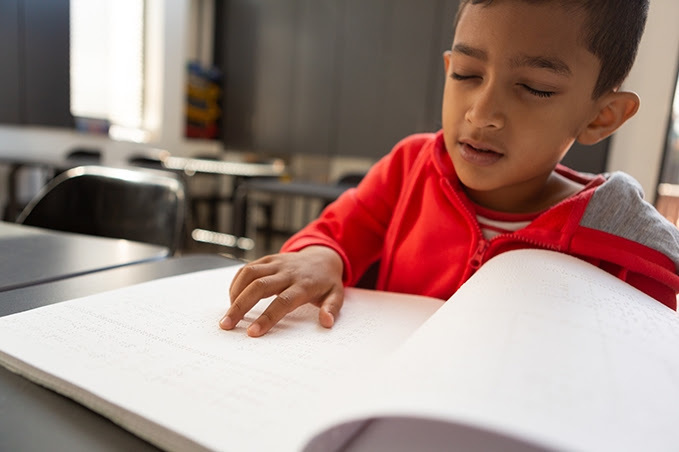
[308,250,679,451]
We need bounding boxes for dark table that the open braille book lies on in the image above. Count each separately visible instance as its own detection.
[0,255,238,452]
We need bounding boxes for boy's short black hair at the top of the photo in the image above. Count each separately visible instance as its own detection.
[455,0,649,99]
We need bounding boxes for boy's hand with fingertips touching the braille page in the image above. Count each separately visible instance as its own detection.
[219,246,344,337]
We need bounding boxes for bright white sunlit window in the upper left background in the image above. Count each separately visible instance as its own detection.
[70,0,145,141]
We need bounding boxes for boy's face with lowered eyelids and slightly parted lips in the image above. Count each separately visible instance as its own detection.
[442,0,600,212]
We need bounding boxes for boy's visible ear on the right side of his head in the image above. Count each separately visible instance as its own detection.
[577,91,640,144]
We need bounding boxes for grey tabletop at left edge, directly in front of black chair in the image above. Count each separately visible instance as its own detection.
[0,222,167,292]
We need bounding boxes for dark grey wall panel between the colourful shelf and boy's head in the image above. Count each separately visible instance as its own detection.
[216,0,456,161]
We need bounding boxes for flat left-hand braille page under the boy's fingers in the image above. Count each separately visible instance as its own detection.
[0,267,442,450]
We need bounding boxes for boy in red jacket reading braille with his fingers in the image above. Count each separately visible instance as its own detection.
[220,0,679,337]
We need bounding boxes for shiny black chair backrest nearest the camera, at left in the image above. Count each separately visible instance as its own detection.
[17,166,185,255]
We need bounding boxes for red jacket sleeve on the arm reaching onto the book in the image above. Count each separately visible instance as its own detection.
[281,134,431,285]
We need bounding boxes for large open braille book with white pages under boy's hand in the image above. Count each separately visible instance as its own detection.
[0,250,679,451]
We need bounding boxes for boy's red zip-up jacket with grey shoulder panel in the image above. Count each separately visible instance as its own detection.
[282,132,679,309]
